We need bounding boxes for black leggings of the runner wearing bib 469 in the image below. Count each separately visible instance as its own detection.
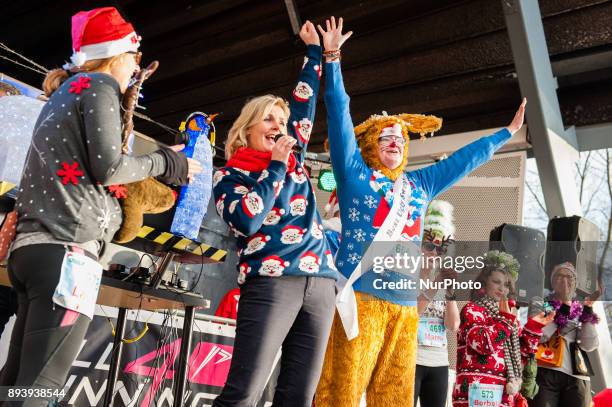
[414,365,448,407]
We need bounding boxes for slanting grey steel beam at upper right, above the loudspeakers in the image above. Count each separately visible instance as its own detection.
[502,0,582,218]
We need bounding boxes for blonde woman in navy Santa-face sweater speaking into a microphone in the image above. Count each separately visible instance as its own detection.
[213,22,338,406]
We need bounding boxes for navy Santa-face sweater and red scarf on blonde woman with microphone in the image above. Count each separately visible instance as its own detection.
[213,45,337,284]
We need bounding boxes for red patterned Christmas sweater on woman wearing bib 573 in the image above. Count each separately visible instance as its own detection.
[453,302,543,407]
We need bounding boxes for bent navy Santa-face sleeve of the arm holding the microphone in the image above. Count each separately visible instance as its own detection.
[213,160,287,236]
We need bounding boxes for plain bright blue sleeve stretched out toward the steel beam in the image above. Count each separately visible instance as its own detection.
[410,128,512,199]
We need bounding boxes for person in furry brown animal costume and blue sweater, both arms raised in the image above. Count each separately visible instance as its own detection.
[316,17,526,407]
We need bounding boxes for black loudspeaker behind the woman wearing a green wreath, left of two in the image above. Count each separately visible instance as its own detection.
[489,223,546,305]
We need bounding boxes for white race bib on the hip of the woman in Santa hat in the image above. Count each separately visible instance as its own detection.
[53,251,102,319]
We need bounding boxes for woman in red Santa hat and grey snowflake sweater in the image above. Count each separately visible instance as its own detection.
[0,7,201,400]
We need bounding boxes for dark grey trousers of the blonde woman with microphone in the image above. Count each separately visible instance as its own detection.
[213,276,336,407]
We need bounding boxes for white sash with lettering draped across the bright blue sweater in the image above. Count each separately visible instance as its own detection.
[336,174,411,341]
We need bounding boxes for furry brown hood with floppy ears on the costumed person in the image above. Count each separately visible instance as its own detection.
[355,112,442,180]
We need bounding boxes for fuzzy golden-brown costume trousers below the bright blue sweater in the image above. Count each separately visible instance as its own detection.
[315,292,419,407]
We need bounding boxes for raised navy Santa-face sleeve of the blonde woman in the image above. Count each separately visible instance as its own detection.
[287,45,322,162]
